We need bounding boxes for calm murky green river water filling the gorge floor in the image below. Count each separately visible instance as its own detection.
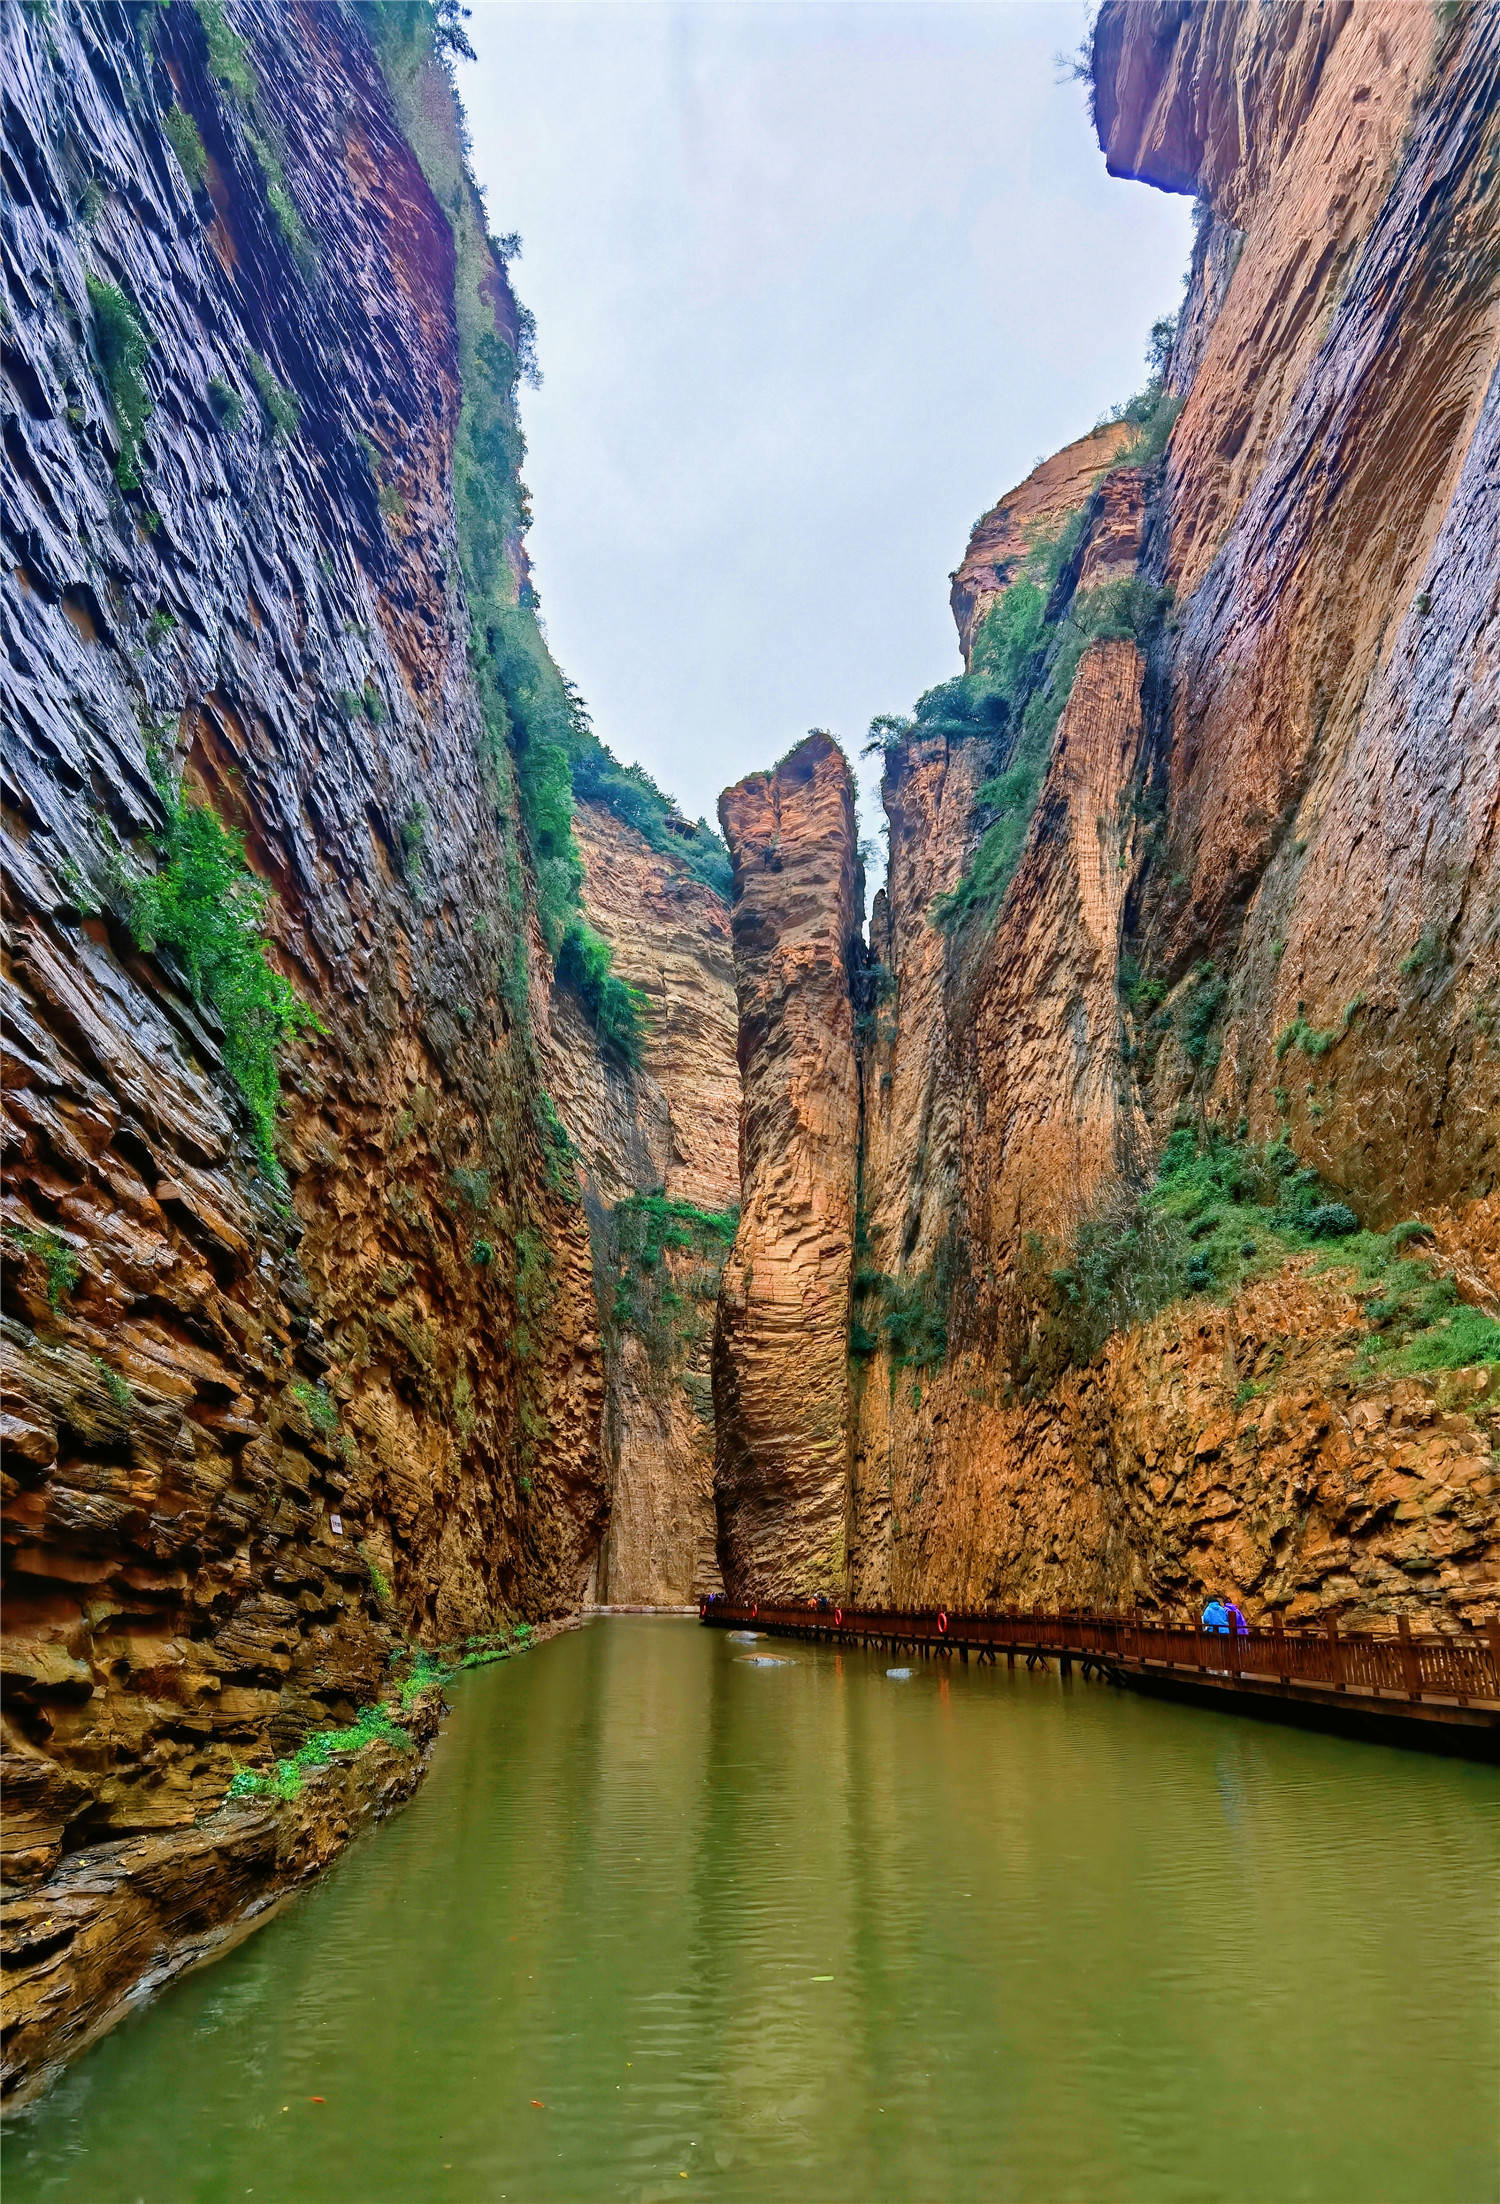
[4,1618,1500,2204]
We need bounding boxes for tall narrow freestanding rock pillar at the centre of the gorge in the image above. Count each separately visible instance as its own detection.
[714,734,861,1598]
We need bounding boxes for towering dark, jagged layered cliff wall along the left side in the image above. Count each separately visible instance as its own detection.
[2,4,608,2081]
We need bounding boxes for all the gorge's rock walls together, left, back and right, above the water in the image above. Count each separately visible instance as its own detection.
[0,0,1500,2111]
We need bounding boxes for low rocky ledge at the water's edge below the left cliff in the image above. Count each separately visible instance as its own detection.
[0,1611,588,2120]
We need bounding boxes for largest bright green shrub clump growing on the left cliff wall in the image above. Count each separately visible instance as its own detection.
[130,776,324,1184]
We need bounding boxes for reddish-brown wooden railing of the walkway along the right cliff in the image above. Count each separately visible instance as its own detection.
[698,1598,1500,1708]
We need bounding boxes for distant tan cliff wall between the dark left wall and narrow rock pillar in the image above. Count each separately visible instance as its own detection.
[548,802,740,1607]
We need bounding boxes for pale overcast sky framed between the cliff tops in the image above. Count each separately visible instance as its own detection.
[460,0,1189,850]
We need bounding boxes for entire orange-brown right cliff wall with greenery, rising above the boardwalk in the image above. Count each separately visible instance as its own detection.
[718,0,1500,1627]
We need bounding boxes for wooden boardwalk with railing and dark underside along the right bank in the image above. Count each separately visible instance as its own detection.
[698,1598,1500,1761]
